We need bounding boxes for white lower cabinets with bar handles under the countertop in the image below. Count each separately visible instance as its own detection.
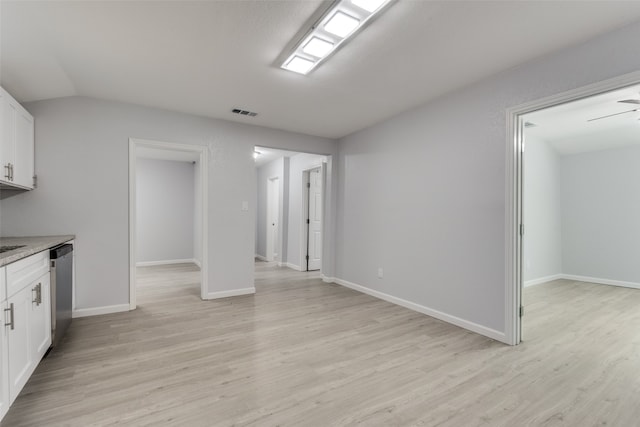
[0,253,51,419]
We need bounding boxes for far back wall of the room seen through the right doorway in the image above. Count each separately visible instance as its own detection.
[561,146,640,284]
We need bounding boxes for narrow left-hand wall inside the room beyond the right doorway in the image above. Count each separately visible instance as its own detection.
[523,137,562,285]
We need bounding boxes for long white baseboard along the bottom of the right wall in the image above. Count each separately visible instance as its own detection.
[332,278,509,344]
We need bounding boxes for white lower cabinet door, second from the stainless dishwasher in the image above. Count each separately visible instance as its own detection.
[5,286,35,403]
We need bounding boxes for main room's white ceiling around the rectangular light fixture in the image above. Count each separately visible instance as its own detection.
[0,0,640,138]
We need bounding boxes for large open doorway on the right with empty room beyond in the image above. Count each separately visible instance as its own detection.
[510,78,640,343]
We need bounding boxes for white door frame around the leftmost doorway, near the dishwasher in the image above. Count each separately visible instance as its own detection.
[129,138,209,310]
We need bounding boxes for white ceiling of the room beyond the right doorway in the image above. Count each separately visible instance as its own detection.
[523,86,640,155]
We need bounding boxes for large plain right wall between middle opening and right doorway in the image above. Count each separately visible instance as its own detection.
[336,24,640,340]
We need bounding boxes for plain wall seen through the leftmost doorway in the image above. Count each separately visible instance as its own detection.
[136,158,196,263]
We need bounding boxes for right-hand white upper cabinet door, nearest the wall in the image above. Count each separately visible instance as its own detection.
[12,107,34,188]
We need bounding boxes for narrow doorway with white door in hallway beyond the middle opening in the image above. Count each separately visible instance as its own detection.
[301,168,323,271]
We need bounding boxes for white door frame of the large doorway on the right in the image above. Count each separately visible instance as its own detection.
[505,71,640,345]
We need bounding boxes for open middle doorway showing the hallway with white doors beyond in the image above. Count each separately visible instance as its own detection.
[255,147,330,277]
